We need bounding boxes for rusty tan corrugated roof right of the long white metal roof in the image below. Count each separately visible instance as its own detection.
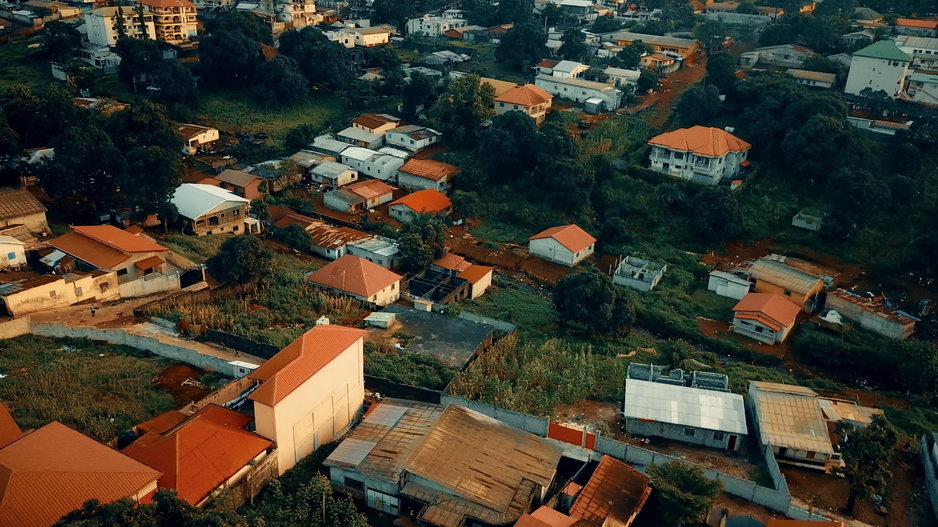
[749,381,834,455]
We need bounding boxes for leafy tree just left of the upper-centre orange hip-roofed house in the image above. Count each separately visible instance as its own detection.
[430,75,495,146]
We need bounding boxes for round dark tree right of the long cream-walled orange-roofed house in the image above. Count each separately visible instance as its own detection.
[205,234,273,288]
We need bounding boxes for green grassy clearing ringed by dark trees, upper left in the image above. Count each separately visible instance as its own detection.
[200,90,343,146]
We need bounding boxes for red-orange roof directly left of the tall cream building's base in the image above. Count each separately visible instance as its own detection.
[123,405,273,505]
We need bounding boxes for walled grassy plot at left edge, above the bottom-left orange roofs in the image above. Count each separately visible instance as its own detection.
[0,335,174,441]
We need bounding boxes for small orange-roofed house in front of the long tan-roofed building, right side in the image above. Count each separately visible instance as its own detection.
[733,293,801,344]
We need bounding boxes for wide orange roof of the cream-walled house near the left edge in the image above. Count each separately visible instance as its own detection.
[49,225,168,269]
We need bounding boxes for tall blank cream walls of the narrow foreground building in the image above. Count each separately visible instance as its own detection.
[254,339,365,474]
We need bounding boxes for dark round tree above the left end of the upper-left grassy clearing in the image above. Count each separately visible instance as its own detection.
[199,31,263,84]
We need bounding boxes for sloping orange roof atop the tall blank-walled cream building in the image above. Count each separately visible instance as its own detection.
[248,326,367,406]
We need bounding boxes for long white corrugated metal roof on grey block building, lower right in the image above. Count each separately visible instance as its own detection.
[623,379,748,434]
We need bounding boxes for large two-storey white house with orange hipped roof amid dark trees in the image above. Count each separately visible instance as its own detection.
[648,126,752,185]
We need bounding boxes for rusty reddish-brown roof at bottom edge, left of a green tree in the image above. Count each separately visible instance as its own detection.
[570,456,651,527]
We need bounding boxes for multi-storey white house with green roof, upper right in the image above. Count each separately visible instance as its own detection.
[844,40,912,97]
